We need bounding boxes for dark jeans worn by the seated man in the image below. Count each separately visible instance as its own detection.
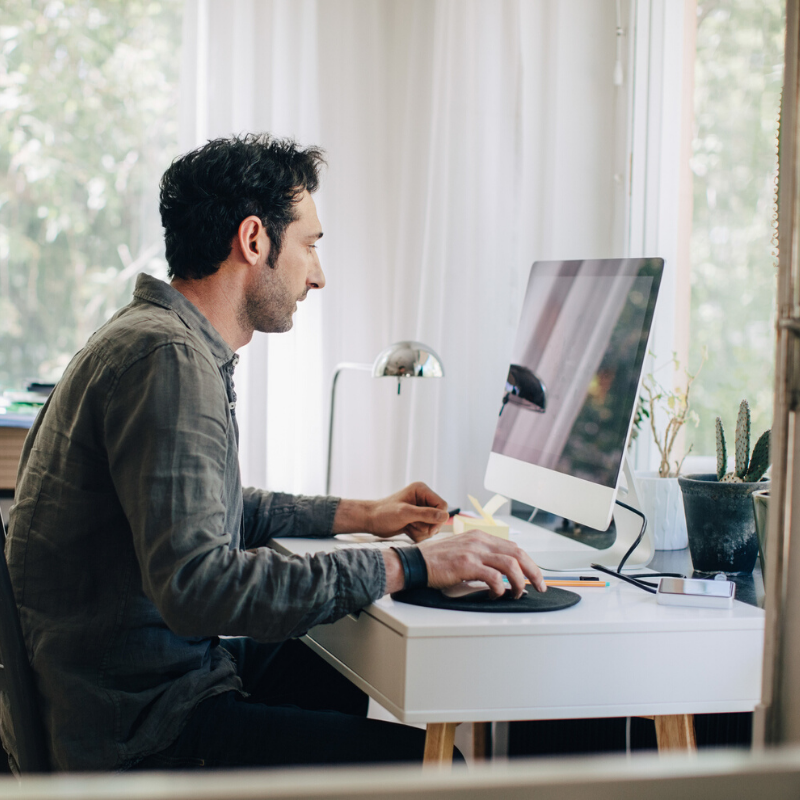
[135,639,440,769]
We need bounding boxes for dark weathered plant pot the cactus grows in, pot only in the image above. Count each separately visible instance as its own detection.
[678,474,769,575]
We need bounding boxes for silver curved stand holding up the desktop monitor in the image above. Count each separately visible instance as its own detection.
[500,456,655,572]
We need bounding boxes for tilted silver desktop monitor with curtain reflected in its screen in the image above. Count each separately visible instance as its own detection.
[485,258,664,530]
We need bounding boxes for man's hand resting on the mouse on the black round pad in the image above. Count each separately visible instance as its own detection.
[384,531,547,598]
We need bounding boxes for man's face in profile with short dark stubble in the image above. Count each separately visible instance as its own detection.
[243,192,325,333]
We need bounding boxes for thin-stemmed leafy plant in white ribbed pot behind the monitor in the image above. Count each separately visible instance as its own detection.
[634,354,705,550]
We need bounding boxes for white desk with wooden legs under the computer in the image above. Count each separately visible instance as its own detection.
[275,521,764,760]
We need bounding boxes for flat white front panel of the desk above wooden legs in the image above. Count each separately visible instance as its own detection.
[405,630,763,722]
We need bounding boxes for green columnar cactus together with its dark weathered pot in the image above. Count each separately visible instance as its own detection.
[678,400,770,575]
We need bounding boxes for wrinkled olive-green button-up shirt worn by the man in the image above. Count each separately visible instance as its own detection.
[0,275,386,770]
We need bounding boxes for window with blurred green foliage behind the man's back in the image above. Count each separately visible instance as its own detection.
[0,0,183,389]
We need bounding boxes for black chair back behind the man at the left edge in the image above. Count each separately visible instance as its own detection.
[0,511,52,773]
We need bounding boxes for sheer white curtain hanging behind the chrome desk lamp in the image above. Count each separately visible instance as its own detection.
[182,0,628,505]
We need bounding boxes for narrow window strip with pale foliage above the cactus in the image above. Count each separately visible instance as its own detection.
[687,0,786,455]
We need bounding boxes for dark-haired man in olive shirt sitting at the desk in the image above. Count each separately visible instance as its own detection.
[0,135,544,769]
